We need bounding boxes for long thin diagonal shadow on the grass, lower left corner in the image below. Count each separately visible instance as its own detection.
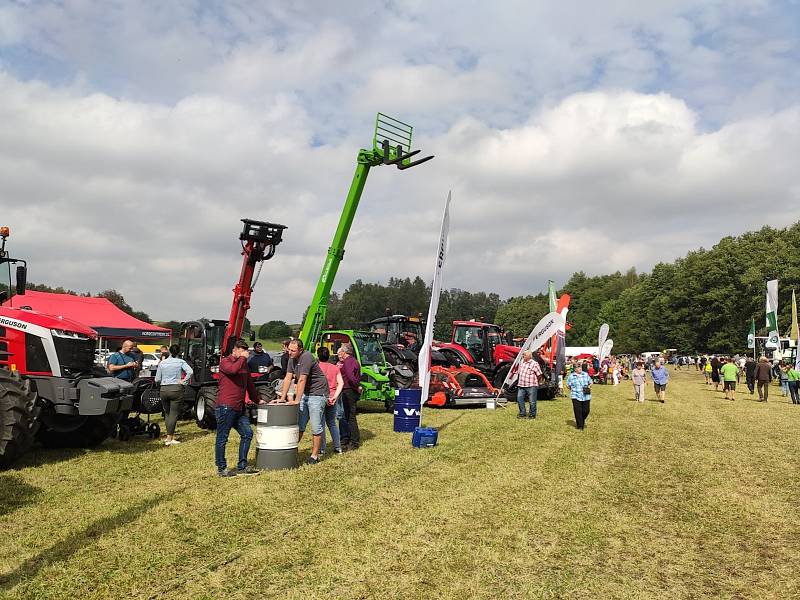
[0,490,175,590]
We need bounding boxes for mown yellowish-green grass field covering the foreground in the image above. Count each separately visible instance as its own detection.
[0,372,800,599]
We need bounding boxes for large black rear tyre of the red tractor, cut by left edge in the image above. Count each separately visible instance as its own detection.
[0,369,36,468]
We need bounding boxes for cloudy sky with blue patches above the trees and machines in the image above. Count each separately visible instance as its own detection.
[0,0,800,322]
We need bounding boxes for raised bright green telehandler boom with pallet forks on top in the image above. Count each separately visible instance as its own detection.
[300,113,433,348]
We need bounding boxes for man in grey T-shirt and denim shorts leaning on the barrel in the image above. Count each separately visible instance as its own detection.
[278,340,329,465]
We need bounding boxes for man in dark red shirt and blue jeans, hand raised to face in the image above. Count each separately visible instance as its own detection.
[214,340,258,477]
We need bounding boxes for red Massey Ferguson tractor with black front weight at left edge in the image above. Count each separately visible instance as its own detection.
[0,227,133,468]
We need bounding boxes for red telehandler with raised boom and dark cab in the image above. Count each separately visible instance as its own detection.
[166,219,286,429]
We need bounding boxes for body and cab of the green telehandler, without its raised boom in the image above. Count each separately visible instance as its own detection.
[315,329,400,412]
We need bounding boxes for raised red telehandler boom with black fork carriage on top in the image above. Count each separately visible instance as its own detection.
[222,219,286,356]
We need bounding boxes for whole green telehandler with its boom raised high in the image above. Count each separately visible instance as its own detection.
[300,113,433,410]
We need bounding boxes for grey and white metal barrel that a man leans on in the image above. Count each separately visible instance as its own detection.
[256,404,300,471]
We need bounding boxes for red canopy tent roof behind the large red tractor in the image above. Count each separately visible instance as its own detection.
[3,290,172,341]
